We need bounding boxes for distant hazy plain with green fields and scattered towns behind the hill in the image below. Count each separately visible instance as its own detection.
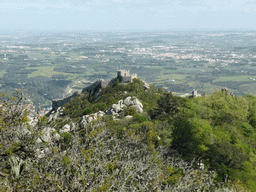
[0,31,256,111]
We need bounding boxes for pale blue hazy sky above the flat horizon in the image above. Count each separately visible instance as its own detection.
[0,0,256,31]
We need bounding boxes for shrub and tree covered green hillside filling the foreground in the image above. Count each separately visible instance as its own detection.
[0,79,256,191]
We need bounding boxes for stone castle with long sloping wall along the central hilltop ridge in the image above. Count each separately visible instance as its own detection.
[52,70,137,111]
